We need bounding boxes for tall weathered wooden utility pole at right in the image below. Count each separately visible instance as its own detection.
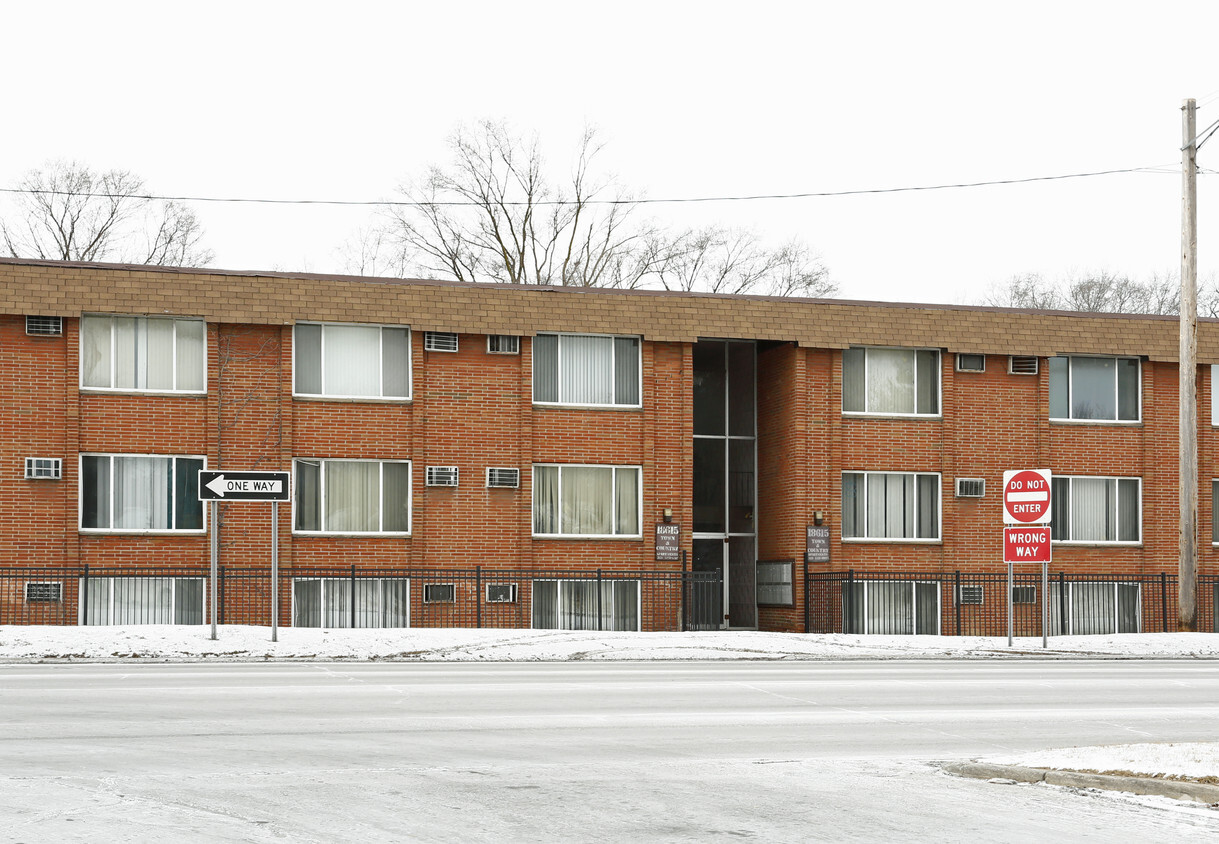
[1178,100,1198,633]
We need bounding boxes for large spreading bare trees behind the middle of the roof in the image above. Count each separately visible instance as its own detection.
[343,122,837,295]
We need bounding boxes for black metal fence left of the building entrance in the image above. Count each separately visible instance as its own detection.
[0,566,723,631]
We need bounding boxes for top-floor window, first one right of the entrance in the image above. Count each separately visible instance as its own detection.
[842,348,940,416]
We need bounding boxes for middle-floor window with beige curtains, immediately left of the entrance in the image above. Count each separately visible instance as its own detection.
[533,463,642,538]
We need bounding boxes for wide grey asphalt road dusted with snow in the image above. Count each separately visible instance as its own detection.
[0,660,1219,842]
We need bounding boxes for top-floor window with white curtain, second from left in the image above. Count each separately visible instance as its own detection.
[293,322,411,400]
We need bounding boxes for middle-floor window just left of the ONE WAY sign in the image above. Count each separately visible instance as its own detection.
[80,454,206,533]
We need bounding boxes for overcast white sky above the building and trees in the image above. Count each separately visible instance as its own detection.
[0,0,1219,302]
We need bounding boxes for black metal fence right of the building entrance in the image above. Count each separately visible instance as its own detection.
[805,571,1219,637]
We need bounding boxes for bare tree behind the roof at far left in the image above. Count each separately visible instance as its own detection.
[0,161,213,266]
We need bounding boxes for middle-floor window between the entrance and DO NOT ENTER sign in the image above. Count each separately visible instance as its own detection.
[842,472,940,539]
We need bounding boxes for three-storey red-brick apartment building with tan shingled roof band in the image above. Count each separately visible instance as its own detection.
[0,260,1219,633]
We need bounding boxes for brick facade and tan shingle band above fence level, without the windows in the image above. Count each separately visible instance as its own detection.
[0,260,1219,631]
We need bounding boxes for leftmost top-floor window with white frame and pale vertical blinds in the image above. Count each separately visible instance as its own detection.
[80,313,207,393]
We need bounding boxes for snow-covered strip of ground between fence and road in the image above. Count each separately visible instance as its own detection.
[0,624,1219,662]
